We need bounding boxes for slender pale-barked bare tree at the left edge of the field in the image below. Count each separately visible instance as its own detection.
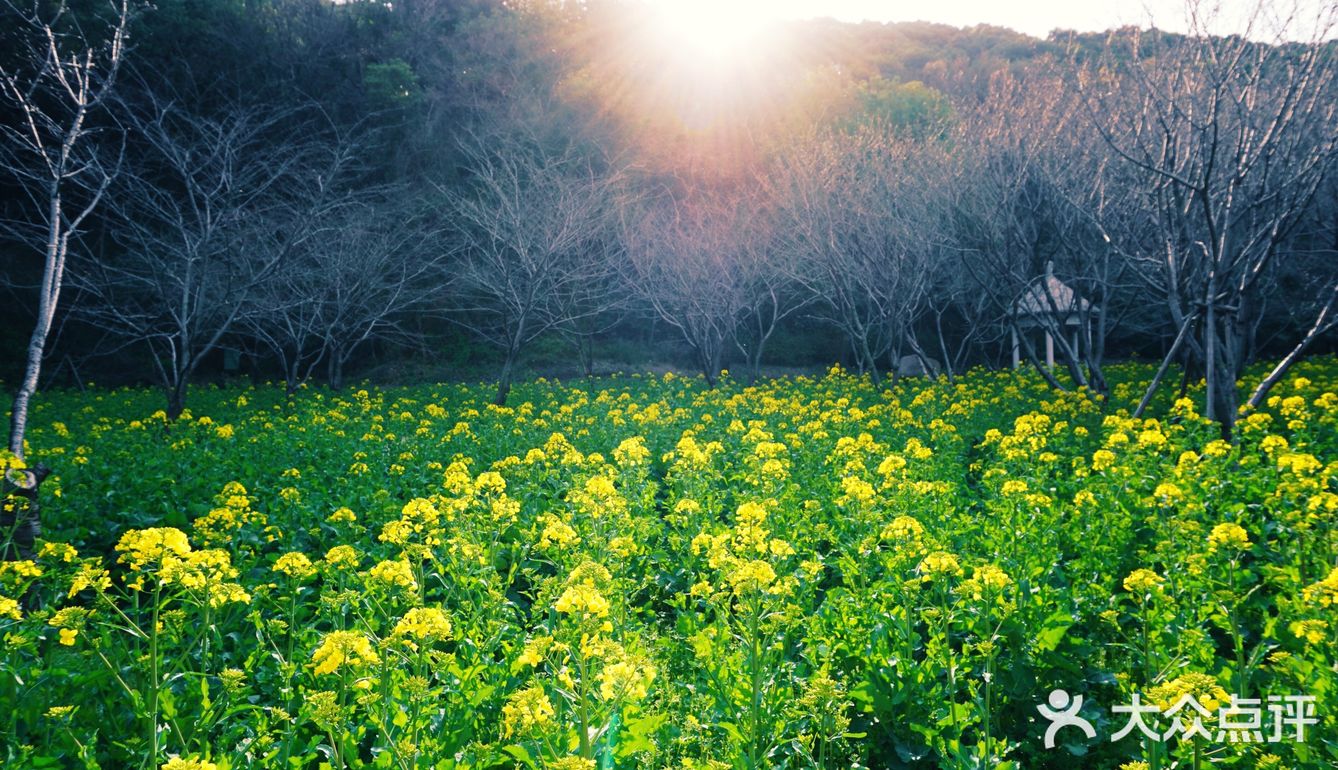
[0,0,132,458]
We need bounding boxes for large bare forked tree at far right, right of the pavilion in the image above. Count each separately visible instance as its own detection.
[1081,3,1338,435]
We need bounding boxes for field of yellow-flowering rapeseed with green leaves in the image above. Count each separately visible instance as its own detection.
[0,360,1338,770]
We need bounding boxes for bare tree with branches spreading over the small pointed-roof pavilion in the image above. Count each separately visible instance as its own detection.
[947,70,1128,392]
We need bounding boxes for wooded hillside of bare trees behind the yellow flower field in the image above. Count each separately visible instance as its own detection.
[0,0,1338,433]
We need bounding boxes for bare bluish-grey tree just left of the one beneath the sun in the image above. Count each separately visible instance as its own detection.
[442,129,617,404]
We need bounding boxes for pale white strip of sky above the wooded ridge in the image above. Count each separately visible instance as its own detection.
[660,0,1338,40]
